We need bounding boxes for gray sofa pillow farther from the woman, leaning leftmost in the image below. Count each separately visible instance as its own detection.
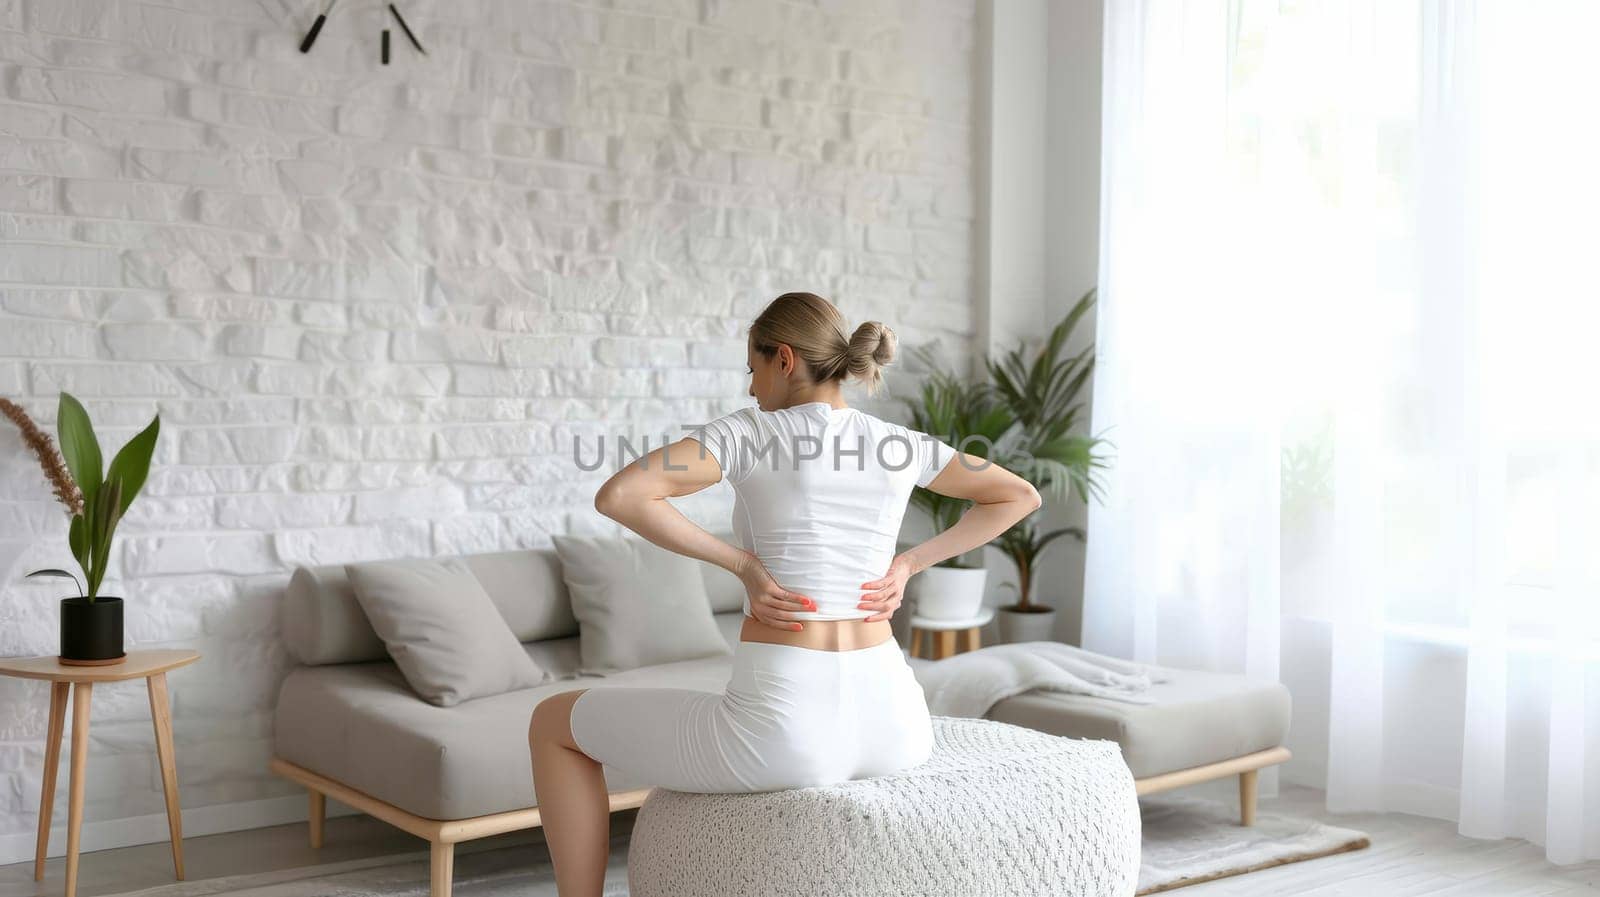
[344,558,554,707]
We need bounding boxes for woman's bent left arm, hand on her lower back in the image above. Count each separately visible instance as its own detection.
[595,437,816,632]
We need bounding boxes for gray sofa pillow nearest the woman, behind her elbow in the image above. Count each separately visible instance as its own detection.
[554,536,733,675]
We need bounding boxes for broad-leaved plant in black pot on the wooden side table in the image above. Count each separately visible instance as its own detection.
[0,392,162,667]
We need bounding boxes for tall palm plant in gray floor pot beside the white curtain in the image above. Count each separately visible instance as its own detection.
[984,289,1106,643]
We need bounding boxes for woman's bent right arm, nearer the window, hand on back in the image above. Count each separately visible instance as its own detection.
[858,452,1042,620]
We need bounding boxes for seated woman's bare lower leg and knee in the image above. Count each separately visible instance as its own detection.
[528,689,611,897]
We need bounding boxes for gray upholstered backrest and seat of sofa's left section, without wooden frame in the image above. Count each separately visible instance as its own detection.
[274,548,742,819]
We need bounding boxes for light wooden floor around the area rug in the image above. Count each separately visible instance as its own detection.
[0,787,1600,897]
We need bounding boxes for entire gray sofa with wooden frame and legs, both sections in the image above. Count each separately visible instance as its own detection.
[270,537,1288,897]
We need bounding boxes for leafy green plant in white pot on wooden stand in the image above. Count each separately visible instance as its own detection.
[901,338,1011,620]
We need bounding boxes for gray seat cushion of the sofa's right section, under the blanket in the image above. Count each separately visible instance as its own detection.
[979,659,1290,779]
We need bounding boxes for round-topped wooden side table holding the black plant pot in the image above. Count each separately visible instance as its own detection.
[0,649,200,897]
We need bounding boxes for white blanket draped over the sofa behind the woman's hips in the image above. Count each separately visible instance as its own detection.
[907,641,1166,718]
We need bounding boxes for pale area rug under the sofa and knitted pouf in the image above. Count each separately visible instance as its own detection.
[103,798,1368,897]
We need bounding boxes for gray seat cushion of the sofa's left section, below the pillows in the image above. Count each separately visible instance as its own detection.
[272,614,742,819]
